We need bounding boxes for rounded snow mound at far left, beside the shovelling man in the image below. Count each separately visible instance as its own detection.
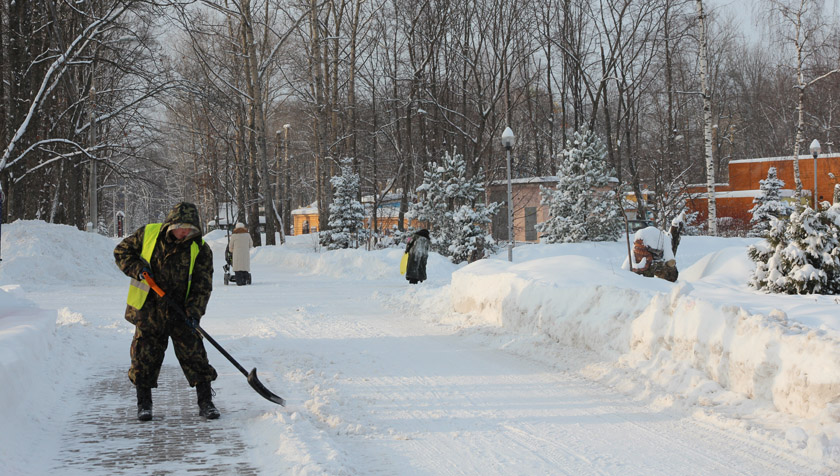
[0,220,124,287]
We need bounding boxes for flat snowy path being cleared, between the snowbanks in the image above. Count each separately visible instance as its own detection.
[23,256,827,476]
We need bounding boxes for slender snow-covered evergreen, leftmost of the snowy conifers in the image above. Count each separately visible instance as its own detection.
[321,159,365,250]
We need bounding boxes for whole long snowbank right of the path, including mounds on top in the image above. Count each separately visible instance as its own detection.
[447,237,840,455]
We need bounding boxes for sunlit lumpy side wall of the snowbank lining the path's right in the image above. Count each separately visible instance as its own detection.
[451,256,840,418]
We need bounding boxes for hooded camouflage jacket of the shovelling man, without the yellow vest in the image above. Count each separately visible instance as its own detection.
[114,203,213,328]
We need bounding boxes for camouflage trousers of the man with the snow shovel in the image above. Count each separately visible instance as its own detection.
[128,323,217,388]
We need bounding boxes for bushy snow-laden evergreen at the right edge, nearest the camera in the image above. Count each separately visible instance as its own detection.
[748,204,840,294]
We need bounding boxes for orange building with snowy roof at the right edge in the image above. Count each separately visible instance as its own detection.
[686,154,840,228]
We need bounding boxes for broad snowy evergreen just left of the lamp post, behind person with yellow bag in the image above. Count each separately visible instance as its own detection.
[408,152,500,263]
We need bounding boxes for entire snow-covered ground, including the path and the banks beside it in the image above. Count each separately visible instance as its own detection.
[0,221,840,475]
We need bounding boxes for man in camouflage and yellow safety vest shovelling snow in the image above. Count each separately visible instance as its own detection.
[114,202,220,421]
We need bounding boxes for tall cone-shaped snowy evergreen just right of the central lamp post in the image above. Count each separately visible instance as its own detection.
[536,131,623,243]
